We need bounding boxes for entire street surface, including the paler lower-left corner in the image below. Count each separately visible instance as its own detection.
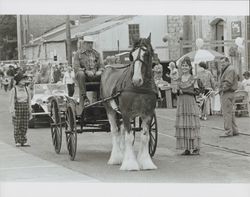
[0,90,250,183]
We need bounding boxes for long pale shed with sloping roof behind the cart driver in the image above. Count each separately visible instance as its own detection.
[24,16,169,62]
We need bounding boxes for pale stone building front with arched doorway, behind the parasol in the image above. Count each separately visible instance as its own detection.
[192,16,250,75]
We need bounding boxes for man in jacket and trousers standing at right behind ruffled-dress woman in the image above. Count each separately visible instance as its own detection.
[219,57,239,137]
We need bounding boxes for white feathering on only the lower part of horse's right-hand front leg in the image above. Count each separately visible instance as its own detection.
[137,132,157,170]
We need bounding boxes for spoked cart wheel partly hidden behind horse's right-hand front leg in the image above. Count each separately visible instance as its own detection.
[148,114,158,157]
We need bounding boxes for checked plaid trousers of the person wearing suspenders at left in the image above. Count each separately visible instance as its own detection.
[12,102,30,144]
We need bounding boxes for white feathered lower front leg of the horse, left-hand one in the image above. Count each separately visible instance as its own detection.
[120,132,139,170]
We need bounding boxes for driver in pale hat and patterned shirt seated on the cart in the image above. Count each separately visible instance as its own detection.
[73,36,104,109]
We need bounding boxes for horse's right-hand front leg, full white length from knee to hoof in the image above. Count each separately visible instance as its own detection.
[137,117,157,170]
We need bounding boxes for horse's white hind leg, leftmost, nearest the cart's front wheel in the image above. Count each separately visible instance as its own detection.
[108,111,123,165]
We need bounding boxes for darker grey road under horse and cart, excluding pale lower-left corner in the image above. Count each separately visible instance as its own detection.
[0,90,250,183]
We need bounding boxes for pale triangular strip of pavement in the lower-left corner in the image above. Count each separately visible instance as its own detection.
[0,141,99,183]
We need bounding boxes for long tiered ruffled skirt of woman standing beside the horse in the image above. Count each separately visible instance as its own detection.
[175,94,201,150]
